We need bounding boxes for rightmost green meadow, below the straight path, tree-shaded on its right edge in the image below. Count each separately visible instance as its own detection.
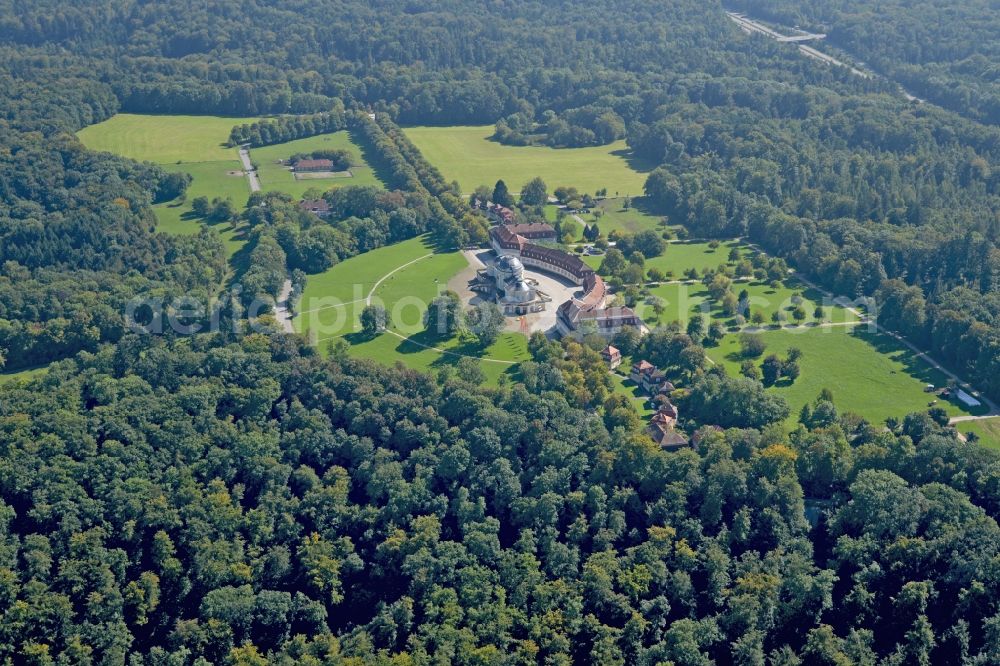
[707,325,988,423]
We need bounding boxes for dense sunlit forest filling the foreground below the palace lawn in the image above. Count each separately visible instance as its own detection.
[0,335,1000,665]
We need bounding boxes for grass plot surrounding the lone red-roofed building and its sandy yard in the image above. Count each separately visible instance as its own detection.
[250,130,385,199]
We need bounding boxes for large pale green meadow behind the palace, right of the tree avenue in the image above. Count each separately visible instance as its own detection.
[405,125,648,196]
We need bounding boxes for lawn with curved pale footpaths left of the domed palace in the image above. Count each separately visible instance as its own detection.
[293,237,528,383]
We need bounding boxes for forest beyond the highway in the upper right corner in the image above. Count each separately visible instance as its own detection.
[726,0,1000,125]
